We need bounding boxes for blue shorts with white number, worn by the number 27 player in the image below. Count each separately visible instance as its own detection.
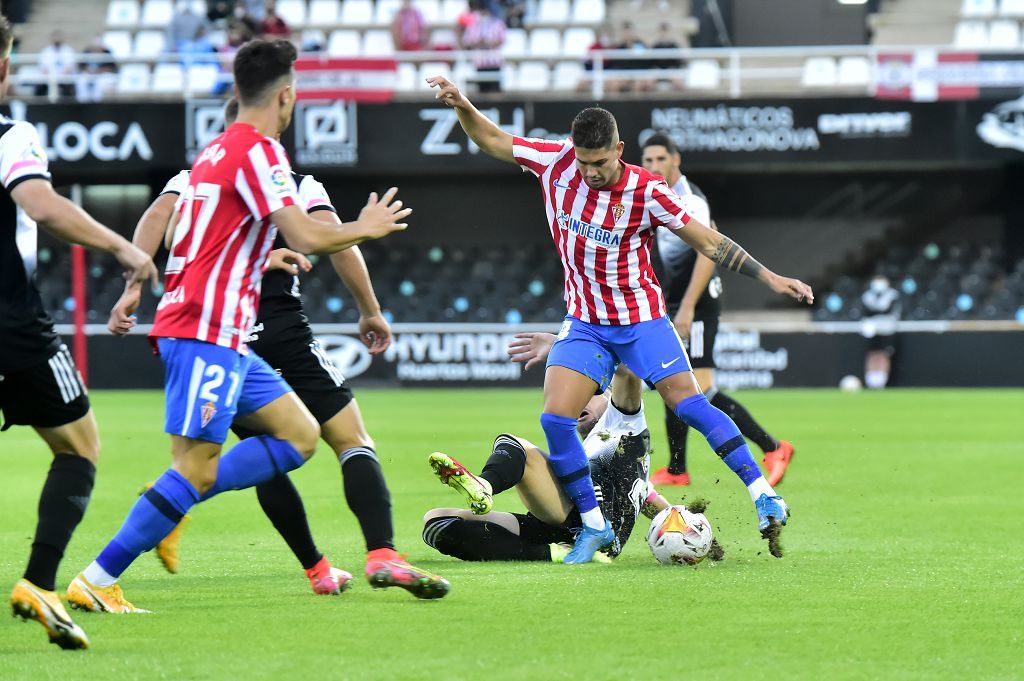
[157,338,292,444]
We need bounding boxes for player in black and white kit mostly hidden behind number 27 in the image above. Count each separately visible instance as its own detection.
[108,99,450,598]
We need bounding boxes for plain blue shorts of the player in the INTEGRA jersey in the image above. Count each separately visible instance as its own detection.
[548,316,690,390]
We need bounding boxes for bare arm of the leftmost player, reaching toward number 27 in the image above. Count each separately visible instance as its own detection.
[10,179,158,285]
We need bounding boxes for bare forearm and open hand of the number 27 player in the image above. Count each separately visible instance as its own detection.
[270,186,413,254]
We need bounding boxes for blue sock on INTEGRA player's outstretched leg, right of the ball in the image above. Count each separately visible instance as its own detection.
[675,394,775,500]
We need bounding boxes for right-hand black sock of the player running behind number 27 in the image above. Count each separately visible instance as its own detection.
[338,446,394,551]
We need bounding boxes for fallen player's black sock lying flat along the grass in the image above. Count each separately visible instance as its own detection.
[423,516,551,561]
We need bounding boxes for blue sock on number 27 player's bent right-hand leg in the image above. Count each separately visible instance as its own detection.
[203,435,306,501]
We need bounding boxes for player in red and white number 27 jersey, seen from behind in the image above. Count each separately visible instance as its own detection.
[68,40,410,612]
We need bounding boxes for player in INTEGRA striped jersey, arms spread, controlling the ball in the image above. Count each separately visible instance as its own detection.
[427,77,813,563]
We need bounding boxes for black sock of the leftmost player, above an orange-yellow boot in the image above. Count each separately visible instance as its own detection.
[25,454,96,591]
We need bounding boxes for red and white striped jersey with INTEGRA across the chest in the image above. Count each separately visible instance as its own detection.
[512,137,690,326]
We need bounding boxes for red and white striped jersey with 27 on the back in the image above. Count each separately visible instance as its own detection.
[150,123,302,353]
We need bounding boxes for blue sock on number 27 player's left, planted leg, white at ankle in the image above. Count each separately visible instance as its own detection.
[85,470,199,587]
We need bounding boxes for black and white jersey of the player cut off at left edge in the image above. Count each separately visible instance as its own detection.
[0,116,60,374]
